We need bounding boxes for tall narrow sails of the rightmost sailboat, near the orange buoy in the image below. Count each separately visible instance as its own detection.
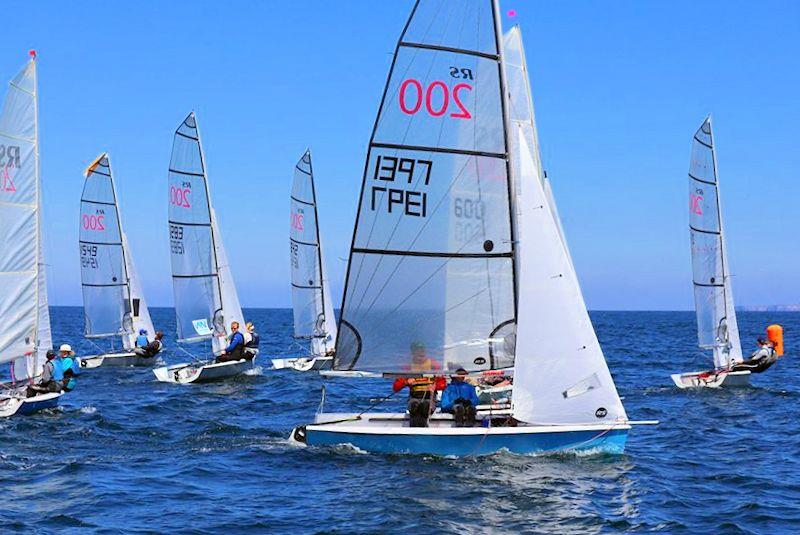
[689,117,742,368]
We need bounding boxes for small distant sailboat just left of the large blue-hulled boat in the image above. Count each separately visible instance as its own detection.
[272,150,336,371]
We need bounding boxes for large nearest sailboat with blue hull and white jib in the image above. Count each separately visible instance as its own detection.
[292,0,644,455]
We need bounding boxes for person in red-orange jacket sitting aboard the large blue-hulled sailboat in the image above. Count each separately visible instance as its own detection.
[392,342,447,427]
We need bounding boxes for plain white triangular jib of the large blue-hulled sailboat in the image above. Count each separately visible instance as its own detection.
[512,127,627,424]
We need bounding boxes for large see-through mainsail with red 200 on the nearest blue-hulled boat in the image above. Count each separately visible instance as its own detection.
[334,0,516,373]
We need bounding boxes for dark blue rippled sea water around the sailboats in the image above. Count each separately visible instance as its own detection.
[0,307,800,533]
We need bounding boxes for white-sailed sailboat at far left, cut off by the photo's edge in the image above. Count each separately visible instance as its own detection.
[0,51,63,417]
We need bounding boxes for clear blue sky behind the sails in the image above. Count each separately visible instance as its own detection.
[0,0,800,310]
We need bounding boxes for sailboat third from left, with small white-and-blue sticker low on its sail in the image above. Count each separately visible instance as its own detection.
[153,112,255,383]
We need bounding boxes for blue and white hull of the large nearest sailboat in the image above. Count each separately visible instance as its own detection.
[291,413,631,456]
